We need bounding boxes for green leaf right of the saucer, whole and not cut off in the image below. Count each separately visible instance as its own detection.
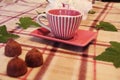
[95,21,117,31]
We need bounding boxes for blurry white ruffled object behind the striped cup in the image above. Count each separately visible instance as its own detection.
[46,0,92,20]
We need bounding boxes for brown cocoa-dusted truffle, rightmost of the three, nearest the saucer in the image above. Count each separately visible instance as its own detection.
[25,48,43,68]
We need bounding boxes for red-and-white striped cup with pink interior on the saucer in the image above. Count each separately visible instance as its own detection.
[36,9,82,40]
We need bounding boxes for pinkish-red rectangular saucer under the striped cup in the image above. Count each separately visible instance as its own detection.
[31,27,97,47]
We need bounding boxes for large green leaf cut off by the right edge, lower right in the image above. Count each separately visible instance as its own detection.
[94,41,120,68]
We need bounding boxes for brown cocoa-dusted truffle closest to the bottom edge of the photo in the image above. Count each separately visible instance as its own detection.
[7,57,27,77]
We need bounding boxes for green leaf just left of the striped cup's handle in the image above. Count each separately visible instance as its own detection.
[16,17,40,29]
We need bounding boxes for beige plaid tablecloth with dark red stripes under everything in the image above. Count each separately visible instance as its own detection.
[0,0,120,80]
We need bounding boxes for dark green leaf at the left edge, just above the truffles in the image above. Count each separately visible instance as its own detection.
[0,25,19,43]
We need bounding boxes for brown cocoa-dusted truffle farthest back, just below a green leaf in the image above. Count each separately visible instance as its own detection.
[5,39,22,57]
